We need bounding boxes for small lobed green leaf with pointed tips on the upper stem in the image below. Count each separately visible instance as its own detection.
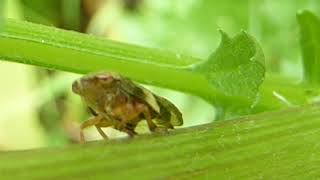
[195,31,265,100]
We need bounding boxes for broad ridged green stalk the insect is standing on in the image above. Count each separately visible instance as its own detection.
[0,104,320,180]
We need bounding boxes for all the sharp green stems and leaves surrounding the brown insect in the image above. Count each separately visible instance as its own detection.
[0,1,320,178]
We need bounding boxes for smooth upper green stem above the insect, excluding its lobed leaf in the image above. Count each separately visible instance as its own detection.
[0,20,316,111]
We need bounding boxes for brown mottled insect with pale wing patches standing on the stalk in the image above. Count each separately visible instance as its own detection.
[72,72,183,143]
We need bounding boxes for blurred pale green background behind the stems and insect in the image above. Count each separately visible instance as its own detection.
[0,0,320,150]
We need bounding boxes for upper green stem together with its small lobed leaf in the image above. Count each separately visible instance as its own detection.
[0,20,316,112]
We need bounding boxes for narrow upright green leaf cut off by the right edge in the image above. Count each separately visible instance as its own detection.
[297,11,320,85]
